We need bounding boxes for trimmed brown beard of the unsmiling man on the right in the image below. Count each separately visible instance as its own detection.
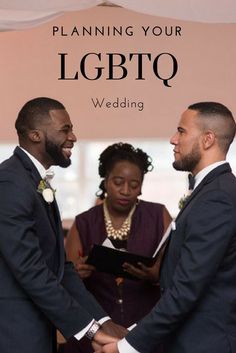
[172,143,201,172]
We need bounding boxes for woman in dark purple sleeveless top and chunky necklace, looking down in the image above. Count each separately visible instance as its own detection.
[65,143,171,353]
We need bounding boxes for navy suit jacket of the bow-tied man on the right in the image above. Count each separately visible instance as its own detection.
[127,163,236,353]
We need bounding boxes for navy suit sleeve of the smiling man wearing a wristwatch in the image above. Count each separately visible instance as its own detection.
[0,173,105,337]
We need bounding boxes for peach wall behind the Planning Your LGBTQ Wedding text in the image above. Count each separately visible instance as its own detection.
[0,7,236,141]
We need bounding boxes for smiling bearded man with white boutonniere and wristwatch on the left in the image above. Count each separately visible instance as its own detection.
[0,97,125,353]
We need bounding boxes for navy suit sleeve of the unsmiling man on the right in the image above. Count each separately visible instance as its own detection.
[127,190,236,353]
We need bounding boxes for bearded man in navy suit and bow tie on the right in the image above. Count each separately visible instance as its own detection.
[97,102,236,353]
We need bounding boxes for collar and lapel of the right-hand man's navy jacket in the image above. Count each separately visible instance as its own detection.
[176,163,232,220]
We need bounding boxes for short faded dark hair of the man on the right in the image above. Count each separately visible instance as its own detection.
[188,102,236,153]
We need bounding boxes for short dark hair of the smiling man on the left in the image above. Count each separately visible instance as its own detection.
[15,97,65,137]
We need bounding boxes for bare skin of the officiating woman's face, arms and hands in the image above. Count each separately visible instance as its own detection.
[66,160,171,283]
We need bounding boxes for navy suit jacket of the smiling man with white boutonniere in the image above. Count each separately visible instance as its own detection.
[0,147,106,353]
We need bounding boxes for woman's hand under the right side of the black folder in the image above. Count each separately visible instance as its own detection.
[123,254,160,284]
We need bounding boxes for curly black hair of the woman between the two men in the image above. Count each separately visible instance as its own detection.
[96,142,153,200]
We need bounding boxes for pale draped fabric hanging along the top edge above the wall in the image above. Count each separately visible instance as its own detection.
[0,0,236,31]
